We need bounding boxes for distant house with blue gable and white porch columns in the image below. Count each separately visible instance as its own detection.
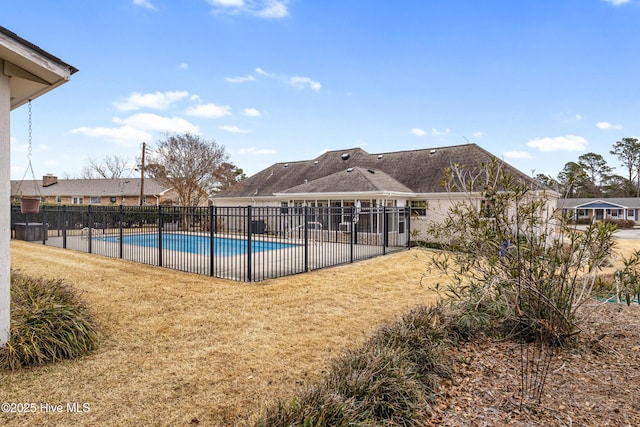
[558,197,640,222]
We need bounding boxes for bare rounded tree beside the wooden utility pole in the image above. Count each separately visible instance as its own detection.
[147,132,228,206]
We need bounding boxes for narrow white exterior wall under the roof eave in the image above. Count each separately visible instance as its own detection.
[0,74,11,347]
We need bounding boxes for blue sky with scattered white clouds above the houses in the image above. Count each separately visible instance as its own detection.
[5,0,640,179]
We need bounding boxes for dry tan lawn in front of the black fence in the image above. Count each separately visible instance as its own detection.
[0,241,435,426]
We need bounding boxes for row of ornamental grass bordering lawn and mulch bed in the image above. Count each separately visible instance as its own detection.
[256,307,451,426]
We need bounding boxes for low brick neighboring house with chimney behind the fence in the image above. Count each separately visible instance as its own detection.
[11,175,176,206]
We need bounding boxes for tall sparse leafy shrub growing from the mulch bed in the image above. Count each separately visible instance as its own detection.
[427,162,617,404]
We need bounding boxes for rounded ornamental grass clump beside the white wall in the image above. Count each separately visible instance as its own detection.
[0,271,98,370]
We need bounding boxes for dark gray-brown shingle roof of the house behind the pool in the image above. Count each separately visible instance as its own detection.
[215,144,539,197]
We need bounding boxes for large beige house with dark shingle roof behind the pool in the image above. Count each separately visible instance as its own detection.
[211,144,559,237]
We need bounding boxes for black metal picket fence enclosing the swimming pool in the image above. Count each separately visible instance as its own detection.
[11,205,410,282]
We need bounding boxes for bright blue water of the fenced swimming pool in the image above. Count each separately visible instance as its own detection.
[102,233,297,255]
